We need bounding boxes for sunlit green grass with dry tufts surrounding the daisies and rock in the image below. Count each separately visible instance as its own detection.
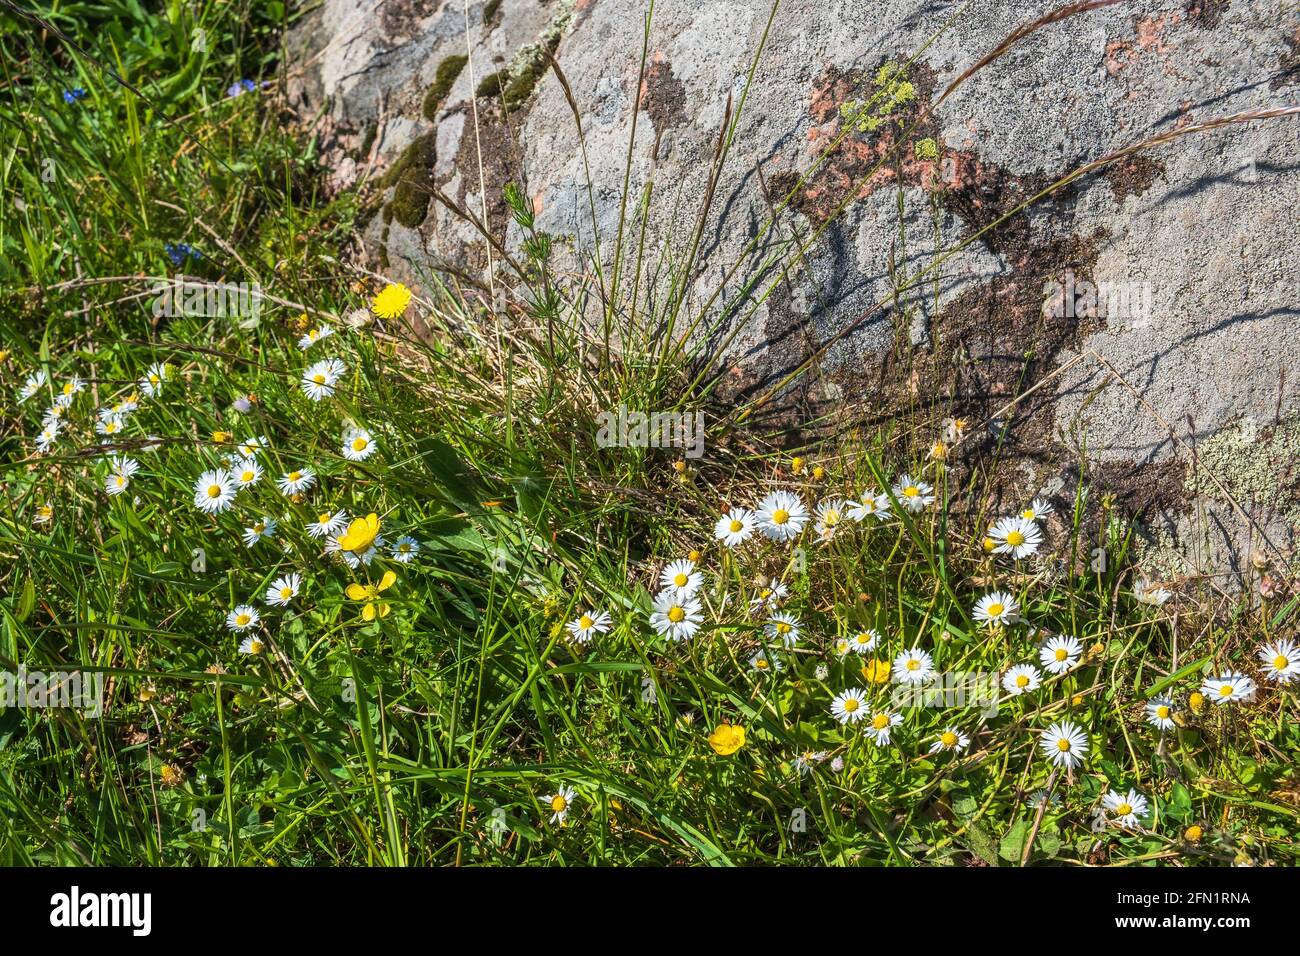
[0,3,1300,865]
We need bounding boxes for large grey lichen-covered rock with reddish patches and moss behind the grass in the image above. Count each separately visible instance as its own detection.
[290,0,1300,587]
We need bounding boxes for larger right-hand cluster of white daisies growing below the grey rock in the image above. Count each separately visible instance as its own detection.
[553,473,1300,829]
